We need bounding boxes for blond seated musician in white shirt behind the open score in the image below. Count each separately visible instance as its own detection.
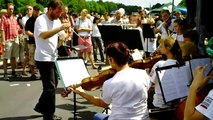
[150,37,184,108]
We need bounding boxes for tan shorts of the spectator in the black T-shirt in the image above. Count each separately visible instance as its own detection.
[28,44,36,66]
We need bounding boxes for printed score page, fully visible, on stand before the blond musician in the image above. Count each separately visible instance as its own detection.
[157,63,192,103]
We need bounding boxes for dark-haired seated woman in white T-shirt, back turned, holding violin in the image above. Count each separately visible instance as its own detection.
[71,42,151,120]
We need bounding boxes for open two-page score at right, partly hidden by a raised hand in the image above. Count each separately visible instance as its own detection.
[156,57,213,103]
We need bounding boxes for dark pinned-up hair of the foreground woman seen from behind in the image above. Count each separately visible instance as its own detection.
[106,42,129,66]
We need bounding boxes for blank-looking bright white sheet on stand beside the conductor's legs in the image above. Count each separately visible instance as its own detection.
[55,58,90,87]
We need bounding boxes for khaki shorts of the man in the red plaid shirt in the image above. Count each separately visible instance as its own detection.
[2,37,19,59]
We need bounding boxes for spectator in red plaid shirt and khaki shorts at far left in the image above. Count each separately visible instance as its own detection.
[0,3,21,80]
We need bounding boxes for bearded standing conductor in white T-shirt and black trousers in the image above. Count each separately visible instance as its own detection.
[34,0,69,120]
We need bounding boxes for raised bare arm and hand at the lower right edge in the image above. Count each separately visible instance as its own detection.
[184,66,211,120]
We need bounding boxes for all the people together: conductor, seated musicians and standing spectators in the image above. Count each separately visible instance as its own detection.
[0,0,213,120]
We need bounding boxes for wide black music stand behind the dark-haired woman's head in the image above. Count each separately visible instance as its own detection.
[98,25,143,50]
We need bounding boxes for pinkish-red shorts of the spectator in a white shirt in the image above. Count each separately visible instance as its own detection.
[78,37,93,53]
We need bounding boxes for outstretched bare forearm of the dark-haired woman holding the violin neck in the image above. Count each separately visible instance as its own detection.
[73,88,108,108]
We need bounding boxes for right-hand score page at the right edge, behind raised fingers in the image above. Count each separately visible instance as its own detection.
[190,58,213,83]
